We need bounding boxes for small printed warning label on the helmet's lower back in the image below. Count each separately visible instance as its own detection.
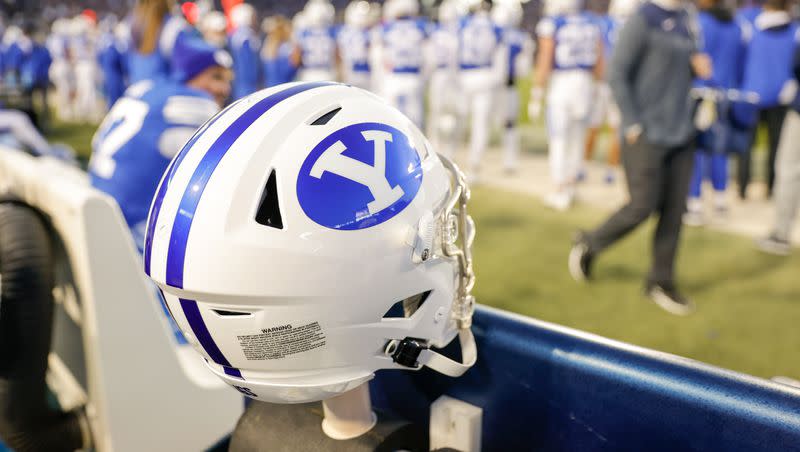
[236,322,325,361]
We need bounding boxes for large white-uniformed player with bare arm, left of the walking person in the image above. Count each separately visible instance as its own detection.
[529,0,603,210]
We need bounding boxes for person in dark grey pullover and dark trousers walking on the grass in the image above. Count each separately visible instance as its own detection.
[569,0,712,315]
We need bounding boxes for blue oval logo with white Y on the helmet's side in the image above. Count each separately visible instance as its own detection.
[297,123,422,230]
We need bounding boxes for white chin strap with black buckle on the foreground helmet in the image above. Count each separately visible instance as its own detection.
[386,328,478,377]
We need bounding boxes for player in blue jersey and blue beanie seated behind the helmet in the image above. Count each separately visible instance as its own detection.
[89,39,232,249]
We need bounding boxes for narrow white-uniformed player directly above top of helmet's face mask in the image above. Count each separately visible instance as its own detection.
[427,0,460,157]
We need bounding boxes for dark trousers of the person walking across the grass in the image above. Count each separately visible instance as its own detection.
[587,137,694,285]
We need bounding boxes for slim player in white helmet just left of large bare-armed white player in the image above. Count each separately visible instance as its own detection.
[492,0,534,173]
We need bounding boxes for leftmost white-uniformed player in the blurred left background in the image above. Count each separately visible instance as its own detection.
[47,18,75,120]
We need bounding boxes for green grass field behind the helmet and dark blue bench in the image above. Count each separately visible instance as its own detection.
[49,123,800,379]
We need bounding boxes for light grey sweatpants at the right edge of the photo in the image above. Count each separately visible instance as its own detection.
[773,110,800,240]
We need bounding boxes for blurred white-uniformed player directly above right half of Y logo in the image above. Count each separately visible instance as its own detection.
[373,0,431,127]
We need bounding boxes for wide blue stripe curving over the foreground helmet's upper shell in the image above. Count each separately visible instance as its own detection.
[166,82,336,289]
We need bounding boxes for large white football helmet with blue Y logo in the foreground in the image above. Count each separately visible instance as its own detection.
[144,82,476,403]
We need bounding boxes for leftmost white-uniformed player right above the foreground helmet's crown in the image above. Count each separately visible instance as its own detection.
[295,0,337,81]
